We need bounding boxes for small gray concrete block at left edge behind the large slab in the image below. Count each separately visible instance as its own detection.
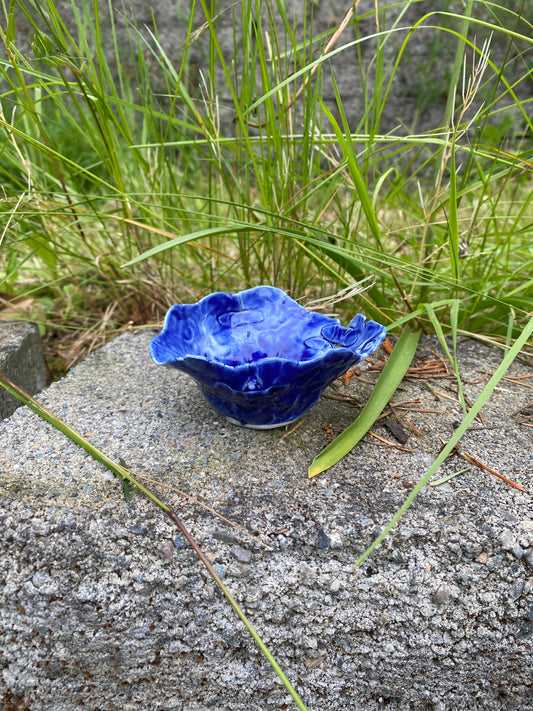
[0,321,46,420]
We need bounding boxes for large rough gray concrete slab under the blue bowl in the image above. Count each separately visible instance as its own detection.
[0,331,533,711]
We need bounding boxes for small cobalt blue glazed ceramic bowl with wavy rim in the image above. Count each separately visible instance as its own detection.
[150,286,386,429]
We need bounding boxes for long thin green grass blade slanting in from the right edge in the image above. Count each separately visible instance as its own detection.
[354,318,533,568]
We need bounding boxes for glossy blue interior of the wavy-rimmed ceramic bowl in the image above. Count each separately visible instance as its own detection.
[150,286,383,367]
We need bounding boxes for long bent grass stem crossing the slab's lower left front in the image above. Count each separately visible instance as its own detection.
[0,374,307,711]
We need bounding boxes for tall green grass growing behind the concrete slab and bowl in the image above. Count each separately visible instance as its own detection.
[0,0,533,368]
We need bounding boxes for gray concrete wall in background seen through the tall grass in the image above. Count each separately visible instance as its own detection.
[8,0,533,133]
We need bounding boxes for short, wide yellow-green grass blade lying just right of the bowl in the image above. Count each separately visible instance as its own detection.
[308,329,420,479]
